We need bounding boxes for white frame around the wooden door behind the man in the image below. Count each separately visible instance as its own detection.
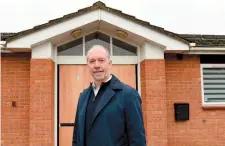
[54,36,141,146]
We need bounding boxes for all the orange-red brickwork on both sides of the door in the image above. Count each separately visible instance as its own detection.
[1,53,225,146]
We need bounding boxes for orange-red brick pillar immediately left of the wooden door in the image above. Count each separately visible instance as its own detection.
[29,59,55,146]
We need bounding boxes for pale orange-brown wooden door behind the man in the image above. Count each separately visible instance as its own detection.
[59,65,136,146]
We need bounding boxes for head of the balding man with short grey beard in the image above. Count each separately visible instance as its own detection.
[87,45,112,82]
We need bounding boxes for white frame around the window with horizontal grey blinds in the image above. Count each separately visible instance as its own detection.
[200,64,225,106]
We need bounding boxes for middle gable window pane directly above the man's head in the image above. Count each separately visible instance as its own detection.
[85,32,110,55]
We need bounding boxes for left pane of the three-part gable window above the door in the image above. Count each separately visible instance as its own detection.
[58,38,83,56]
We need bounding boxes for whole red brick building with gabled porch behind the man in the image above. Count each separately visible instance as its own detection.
[1,2,225,146]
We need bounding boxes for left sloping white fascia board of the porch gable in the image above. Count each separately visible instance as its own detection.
[7,10,99,48]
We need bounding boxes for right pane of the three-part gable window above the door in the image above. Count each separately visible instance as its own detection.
[113,38,137,56]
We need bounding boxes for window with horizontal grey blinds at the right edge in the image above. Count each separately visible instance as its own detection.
[201,64,225,104]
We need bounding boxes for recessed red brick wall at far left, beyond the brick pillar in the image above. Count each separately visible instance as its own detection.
[1,53,30,146]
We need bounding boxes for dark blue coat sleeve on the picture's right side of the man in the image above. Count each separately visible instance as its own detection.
[124,89,146,146]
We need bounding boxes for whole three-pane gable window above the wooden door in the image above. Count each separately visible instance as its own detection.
[57,31,137,60]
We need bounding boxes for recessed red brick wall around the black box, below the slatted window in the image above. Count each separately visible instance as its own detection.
[166,56,225,146]
